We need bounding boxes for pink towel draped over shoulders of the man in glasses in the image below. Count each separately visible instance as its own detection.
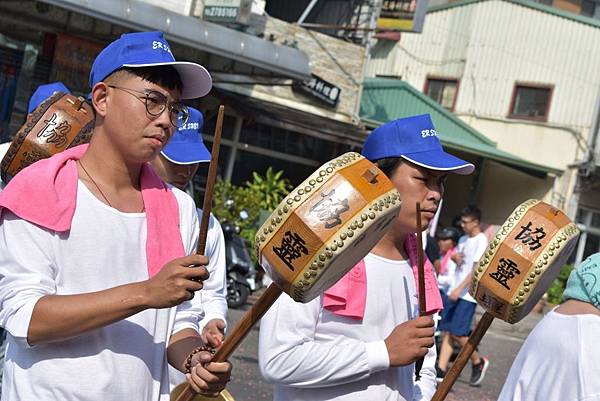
[0,145,185,277]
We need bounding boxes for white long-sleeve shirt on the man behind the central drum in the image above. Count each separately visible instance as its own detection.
[259,254,436,401]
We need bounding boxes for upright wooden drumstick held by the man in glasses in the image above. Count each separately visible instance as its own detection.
[196,105,225,255]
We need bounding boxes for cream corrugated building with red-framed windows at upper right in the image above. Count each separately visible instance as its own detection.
[367,0,600,257]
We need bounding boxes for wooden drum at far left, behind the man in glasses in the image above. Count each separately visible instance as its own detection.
[0,92,94,183]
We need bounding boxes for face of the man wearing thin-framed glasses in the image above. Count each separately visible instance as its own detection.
[92,74,180,163]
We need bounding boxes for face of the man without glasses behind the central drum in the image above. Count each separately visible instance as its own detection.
[391,161,447,232]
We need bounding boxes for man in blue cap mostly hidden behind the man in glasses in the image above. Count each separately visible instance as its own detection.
[151,107,227,386]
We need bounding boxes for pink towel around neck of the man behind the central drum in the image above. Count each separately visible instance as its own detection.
[323,234,443,320]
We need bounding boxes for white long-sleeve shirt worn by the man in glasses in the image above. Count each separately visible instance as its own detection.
[0,182,203,401]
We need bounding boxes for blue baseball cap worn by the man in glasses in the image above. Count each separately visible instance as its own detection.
[90,31,212,99]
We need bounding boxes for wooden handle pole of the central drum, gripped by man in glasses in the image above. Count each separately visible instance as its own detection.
[175,283,283,401]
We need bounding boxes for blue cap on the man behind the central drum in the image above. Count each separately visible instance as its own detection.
[362,114,475,175]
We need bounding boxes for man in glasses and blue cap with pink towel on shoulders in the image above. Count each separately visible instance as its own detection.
[0,32,231,401]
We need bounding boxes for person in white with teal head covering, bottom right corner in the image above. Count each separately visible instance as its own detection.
[498,253,600,401]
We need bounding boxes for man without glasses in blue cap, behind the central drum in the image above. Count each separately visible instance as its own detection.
[259,115,474,401]
